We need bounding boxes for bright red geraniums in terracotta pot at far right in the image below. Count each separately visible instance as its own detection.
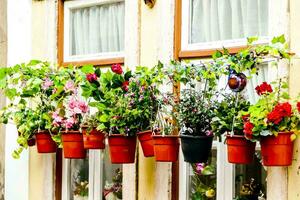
[244,79,299,166]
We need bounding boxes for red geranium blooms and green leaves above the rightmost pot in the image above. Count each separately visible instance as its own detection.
[244,79,300,139]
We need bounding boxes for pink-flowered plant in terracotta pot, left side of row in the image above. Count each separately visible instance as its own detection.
[51,67,89,159]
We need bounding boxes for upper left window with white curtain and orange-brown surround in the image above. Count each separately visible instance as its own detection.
[58,0,125,65]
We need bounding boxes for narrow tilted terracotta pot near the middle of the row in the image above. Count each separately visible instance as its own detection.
[137,130,154,157]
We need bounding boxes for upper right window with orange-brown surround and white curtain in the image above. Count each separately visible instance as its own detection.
[175,0,272,58]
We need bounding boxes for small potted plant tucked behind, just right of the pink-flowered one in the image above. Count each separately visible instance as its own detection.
[81,113,105,149]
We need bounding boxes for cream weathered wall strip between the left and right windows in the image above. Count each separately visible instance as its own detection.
[138,0,174,200]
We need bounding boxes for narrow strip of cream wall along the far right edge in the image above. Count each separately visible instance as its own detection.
[288,0,300,200]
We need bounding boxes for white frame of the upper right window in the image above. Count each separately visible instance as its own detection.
[181,0,274,51]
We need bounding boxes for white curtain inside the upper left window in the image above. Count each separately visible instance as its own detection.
[69,2,125,55]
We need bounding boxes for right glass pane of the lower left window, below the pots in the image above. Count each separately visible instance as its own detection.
[102,148,123,200]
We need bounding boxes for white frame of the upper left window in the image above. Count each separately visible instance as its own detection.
[64,0,125,62]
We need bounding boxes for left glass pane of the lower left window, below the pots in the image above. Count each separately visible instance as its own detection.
[70,156,89,200]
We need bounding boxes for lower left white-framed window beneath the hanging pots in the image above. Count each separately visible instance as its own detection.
[62,145,122,200]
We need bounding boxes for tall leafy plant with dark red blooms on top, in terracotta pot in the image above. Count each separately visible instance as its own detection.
[90,64,140,163]
